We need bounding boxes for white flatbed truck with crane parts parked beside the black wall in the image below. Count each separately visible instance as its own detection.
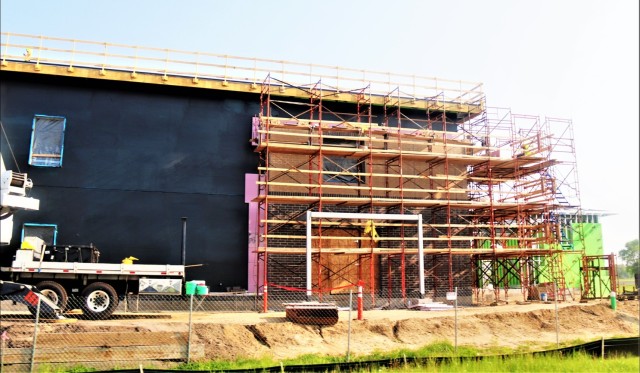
[0,155,185,319]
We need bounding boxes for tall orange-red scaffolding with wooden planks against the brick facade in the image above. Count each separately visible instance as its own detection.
[253,75,580,311]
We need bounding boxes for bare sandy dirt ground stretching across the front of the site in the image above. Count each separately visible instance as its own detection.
[1,300,640,360]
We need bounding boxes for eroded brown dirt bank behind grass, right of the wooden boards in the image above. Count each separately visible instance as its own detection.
[189,301,639,359]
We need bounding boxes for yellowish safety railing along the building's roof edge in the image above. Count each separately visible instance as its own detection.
[0,32,484,105]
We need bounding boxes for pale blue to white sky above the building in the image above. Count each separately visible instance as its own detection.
[0,0,640,253]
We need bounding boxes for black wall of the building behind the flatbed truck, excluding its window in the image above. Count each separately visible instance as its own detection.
[0,71,259,291]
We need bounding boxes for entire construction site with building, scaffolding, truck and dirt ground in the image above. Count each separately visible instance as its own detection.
[0,32,638,372]
